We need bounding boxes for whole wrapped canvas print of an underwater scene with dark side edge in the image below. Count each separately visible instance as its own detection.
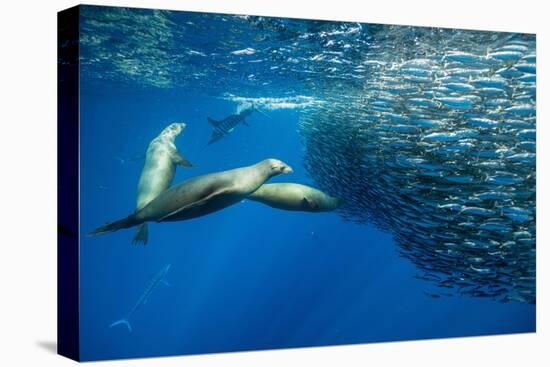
[58,6,536,360]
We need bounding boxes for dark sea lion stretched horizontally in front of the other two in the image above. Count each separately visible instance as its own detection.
[89,159,292,236]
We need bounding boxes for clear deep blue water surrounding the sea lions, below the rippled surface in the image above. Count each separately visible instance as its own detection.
[75,8,535,360]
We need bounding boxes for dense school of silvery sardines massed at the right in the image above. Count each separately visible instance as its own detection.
[300,26,536,303]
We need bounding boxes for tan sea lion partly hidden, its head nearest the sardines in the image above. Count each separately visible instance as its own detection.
[248,183,342,212]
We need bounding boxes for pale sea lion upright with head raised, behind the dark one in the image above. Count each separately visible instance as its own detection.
[132,123,192,245]
